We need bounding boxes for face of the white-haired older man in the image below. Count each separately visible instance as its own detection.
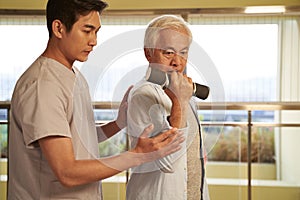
[146,29,190,73]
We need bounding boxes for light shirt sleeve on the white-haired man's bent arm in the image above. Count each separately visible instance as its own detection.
[127,84,184,173]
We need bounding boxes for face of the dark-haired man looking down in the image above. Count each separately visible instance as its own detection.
[61,11,101,63]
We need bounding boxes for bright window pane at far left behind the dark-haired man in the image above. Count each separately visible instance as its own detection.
[0,25,48,101]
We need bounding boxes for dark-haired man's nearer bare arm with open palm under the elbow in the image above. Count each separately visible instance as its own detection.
[39,126,184,187]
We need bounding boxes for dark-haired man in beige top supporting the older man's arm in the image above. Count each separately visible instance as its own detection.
[8,0,184,200]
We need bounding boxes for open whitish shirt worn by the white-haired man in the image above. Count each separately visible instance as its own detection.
[126,80,207,200]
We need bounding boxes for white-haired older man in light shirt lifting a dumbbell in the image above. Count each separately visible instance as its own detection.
[126,15,209,200]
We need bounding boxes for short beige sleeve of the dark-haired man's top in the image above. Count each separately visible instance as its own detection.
[20,80,71,147]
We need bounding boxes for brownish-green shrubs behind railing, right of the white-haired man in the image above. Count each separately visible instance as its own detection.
[208,128,275,163]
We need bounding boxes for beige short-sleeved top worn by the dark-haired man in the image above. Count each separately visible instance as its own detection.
[8,56,102,200]
